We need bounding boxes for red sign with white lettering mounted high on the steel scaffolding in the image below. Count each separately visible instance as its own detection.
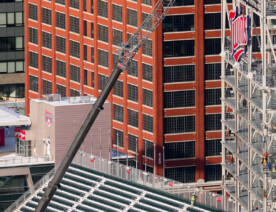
[229,6,250,62]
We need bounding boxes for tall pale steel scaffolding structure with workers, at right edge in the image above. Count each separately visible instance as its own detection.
[221,0,276,212]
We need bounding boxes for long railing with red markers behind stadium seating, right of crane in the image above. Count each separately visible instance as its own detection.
[73,151,234,211]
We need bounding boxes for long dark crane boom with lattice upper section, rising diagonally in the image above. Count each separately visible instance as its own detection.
[35,0,175,212]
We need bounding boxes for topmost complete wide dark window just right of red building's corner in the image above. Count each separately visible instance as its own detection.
[163,15,194,32]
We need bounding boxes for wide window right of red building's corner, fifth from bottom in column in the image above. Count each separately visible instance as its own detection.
[163,65,195,83]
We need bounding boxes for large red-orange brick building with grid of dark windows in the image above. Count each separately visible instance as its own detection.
[25,0,230,189]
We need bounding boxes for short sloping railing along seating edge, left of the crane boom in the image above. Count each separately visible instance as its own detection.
[5,168,56,212]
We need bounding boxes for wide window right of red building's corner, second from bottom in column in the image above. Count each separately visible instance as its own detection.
[165,141,195,160]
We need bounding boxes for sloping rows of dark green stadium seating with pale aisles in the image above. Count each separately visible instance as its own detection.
[18,164,218,212]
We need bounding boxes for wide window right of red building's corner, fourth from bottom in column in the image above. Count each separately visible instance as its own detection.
[164,90,195,108]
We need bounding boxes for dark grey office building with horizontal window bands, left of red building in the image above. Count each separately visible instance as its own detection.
[0,0,25,99]
